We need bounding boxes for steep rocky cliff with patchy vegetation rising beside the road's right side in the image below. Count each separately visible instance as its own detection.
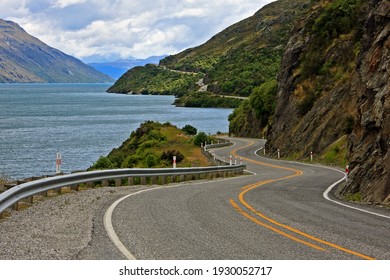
[267,0,390,206]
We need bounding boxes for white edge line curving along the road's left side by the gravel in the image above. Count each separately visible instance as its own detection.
[103,177,250,260]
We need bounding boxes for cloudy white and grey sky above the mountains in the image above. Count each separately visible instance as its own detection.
[0,0,273,62]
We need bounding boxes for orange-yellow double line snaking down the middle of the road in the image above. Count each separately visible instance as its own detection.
[229,142,374,260]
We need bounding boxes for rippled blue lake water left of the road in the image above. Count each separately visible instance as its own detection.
[0,84,232,178]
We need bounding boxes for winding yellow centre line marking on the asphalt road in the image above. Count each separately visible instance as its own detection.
[230,139,373,260]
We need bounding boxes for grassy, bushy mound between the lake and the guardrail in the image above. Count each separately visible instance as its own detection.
[90,121,214,170]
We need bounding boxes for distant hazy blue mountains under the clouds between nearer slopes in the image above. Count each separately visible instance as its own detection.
[88,55,165,79]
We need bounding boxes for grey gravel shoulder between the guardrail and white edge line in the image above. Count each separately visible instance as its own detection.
[0,186,150,260]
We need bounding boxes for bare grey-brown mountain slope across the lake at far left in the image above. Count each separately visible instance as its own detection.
[0,19,113,83]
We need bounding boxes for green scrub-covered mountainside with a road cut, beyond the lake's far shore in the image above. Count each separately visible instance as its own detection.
[109,0,308,107]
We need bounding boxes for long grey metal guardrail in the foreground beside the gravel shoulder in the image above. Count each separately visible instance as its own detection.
[0,165,246,215]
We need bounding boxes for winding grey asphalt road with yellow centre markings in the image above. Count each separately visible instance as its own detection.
[99,139,390,260]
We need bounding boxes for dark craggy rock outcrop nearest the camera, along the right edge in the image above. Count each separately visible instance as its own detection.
[344,0,390,203]
